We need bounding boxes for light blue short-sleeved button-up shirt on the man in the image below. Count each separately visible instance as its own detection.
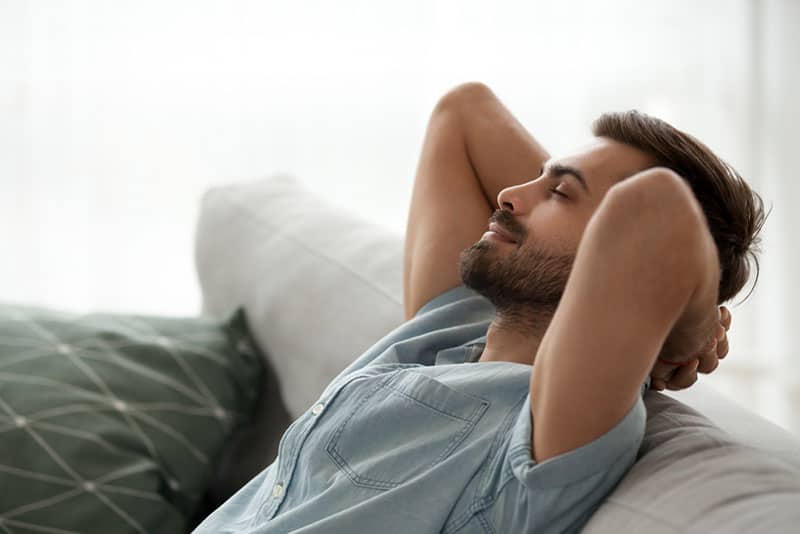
[195,286,649,534]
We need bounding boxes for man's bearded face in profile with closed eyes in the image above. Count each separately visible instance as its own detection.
[460,137,655,314]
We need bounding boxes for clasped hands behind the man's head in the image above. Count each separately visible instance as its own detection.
[650,306,731,391]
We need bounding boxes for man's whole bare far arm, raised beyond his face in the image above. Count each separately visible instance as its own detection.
[403,83,549,320]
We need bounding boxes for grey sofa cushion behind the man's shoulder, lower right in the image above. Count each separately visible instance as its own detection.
[583,391,800,534]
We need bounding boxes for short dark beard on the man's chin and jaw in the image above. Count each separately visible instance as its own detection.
[459,239,575,322]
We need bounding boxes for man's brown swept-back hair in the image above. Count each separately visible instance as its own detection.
[592,110,766,304]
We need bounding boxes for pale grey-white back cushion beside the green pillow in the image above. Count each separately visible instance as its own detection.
[195,175,403,419]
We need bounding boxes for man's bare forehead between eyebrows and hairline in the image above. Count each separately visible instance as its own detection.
[551,137,656,192]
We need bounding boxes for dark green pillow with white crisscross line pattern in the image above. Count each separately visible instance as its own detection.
[0,305,262,533]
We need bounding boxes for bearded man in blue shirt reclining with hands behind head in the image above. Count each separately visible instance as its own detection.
[198,84,764,534]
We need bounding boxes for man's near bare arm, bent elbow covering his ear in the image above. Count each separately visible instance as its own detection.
[530,169,719,462]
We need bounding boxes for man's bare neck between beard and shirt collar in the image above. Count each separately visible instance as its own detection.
[478,311,553,365]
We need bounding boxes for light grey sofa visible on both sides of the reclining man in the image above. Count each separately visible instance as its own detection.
[196,175,800,534]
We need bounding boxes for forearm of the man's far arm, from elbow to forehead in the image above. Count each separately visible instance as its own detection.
[437,83,550,209]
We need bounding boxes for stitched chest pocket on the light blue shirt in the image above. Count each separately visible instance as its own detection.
[326,370,489,489]
